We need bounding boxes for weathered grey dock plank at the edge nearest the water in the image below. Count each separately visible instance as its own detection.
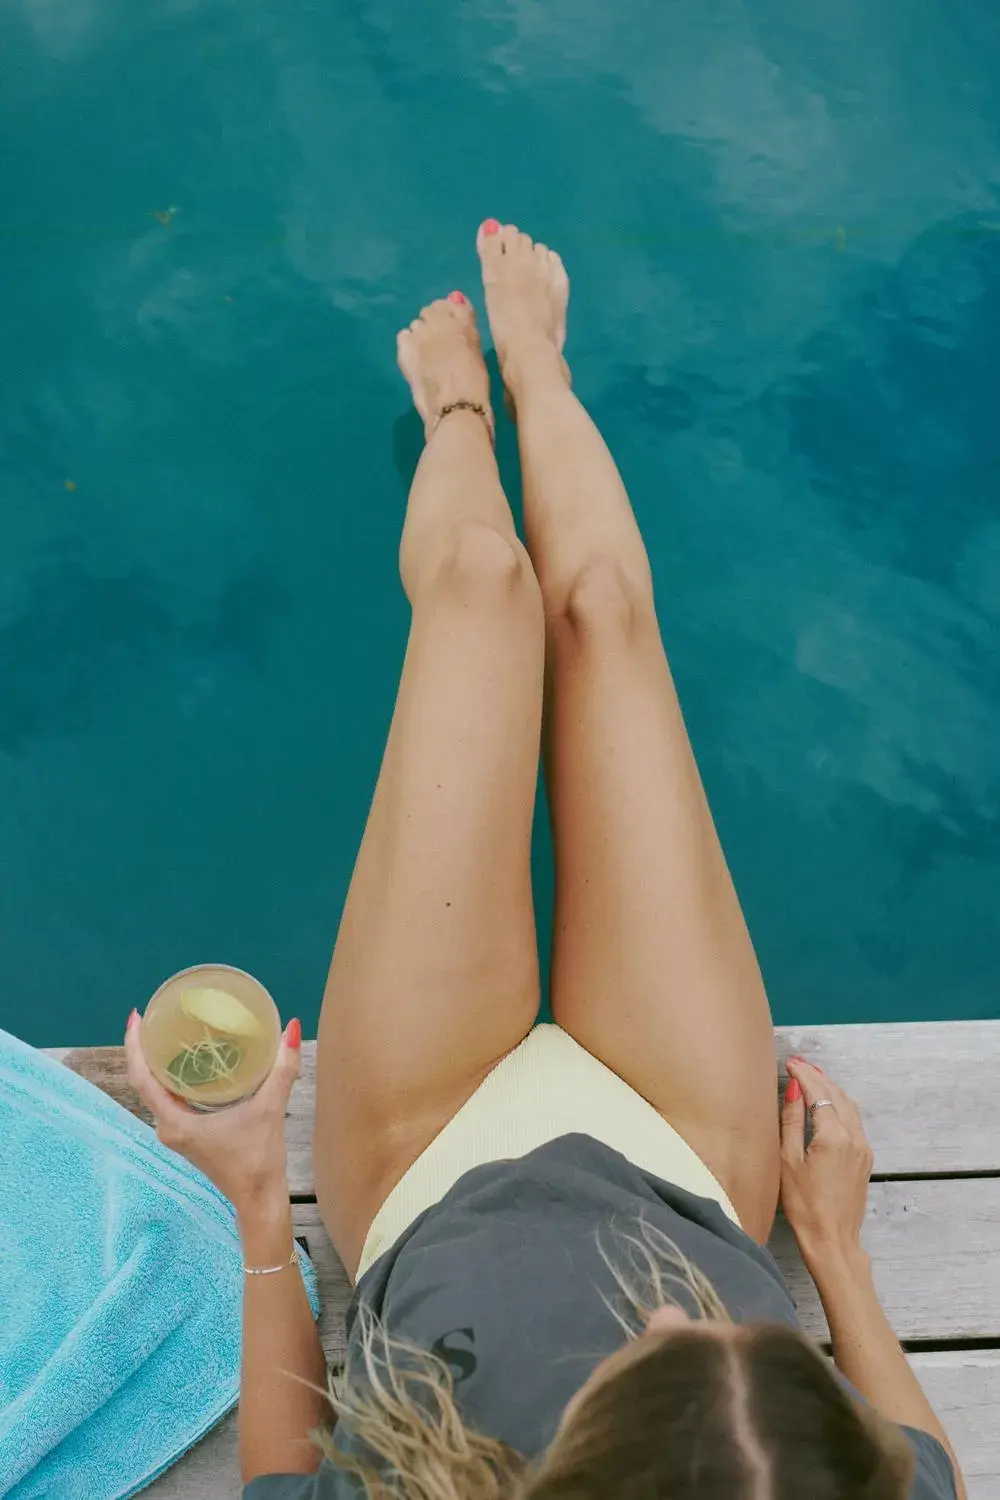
[52,1022,1000,1194]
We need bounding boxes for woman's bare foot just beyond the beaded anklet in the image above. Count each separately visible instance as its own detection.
[396,291,493,438]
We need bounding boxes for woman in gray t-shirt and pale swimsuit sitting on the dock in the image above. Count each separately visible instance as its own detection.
[127,221,964,1500]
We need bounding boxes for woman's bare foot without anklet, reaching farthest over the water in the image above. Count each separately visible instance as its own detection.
[475,219,570,401]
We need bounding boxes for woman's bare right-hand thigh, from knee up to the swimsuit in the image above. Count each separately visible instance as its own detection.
[546,567,780,1241]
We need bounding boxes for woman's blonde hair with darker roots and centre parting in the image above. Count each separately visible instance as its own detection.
[313,1220,912,1500]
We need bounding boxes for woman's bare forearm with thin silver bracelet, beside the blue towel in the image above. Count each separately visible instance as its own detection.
[240,1193,330,1484]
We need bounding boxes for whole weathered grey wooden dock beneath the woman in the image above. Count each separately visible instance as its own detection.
[54,1022,1000,1500]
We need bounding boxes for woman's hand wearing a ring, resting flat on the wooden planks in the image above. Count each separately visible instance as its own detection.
[781,1058,873,1271]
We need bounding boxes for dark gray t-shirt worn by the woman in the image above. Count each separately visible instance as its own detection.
[243,1136,955,1500]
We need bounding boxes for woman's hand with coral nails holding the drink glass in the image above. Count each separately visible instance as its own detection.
[124,1011,301,1217]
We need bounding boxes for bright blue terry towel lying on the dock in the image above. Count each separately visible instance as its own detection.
[0,1031,318,1500]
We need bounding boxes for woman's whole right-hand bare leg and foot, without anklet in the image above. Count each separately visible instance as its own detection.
[478,227,778,1239]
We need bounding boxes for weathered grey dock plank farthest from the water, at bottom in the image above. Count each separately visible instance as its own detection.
[144,1350,1000,1500]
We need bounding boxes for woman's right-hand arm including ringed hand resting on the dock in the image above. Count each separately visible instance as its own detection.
[781,1058,966,1500]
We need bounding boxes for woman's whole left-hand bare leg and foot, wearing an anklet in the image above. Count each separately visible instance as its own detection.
[315,300,544,1274]
